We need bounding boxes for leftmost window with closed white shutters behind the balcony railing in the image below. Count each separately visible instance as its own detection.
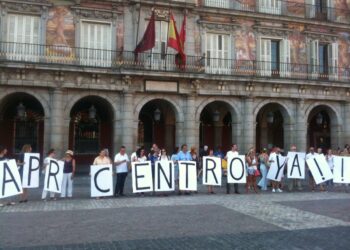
[4,14,41,61]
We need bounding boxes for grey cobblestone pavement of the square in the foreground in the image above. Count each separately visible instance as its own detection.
[0,178,350,249]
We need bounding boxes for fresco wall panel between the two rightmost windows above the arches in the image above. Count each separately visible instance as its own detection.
[288,24,308,65]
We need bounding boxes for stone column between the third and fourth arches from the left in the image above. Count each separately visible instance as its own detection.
[185,95,199,148]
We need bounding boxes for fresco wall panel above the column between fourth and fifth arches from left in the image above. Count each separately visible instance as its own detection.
[235,20,256,68]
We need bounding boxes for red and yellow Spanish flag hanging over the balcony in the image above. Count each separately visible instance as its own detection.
[168,13,186,67]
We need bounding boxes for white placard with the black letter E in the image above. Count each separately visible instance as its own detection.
[131,161,153,193]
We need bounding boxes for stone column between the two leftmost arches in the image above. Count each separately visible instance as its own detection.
[50,88,64,157]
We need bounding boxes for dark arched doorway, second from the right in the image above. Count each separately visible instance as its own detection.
[256,103,286,152]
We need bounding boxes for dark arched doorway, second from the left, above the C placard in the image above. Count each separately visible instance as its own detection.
[69,96,114,166]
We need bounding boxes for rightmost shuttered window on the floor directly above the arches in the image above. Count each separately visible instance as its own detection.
[309,40,338,80]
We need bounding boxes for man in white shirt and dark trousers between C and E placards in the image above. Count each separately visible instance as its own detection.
[114,146,130,197]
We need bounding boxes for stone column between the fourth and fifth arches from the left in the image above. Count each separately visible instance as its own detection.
[242,97,256,154]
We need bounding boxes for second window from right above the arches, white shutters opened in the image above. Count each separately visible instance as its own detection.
[257,38,291,77]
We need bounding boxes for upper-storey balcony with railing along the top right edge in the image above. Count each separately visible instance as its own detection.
[201,0,344,23]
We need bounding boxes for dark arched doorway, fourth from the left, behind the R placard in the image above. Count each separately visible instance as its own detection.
[199,101,232,152]
